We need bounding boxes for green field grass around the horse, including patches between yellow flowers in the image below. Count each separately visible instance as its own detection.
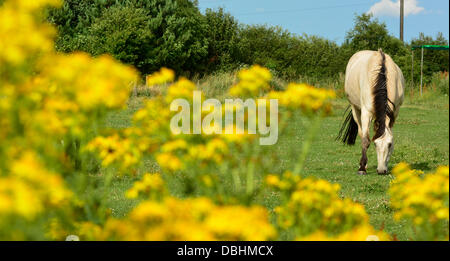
[100,75,449,240]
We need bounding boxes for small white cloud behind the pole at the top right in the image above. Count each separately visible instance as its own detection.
[367,0,425,17]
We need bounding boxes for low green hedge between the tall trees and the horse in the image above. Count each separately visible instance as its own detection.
[239,25,343,79]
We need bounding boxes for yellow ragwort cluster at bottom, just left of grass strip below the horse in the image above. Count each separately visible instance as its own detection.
[265,172,386,240]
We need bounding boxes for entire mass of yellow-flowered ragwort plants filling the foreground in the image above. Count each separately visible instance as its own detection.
[0,0,448,240]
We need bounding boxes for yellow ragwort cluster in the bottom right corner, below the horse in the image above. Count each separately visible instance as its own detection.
[389,163,449,240]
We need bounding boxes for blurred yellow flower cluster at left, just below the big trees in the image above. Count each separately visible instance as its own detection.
[41,53,136,111]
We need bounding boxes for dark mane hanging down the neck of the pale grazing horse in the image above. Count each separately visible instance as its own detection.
[372,49,395,140]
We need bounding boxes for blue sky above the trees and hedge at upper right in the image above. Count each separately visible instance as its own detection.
[198,0,449,43]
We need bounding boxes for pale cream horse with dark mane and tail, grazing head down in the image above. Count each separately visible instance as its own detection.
[337,49,404,175]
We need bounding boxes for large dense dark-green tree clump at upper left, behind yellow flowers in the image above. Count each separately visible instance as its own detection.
[49,0,208,74]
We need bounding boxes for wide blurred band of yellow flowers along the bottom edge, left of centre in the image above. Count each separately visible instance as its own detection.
[79,197,276,241]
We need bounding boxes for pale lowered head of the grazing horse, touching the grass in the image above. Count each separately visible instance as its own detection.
[374,128,394,174]
